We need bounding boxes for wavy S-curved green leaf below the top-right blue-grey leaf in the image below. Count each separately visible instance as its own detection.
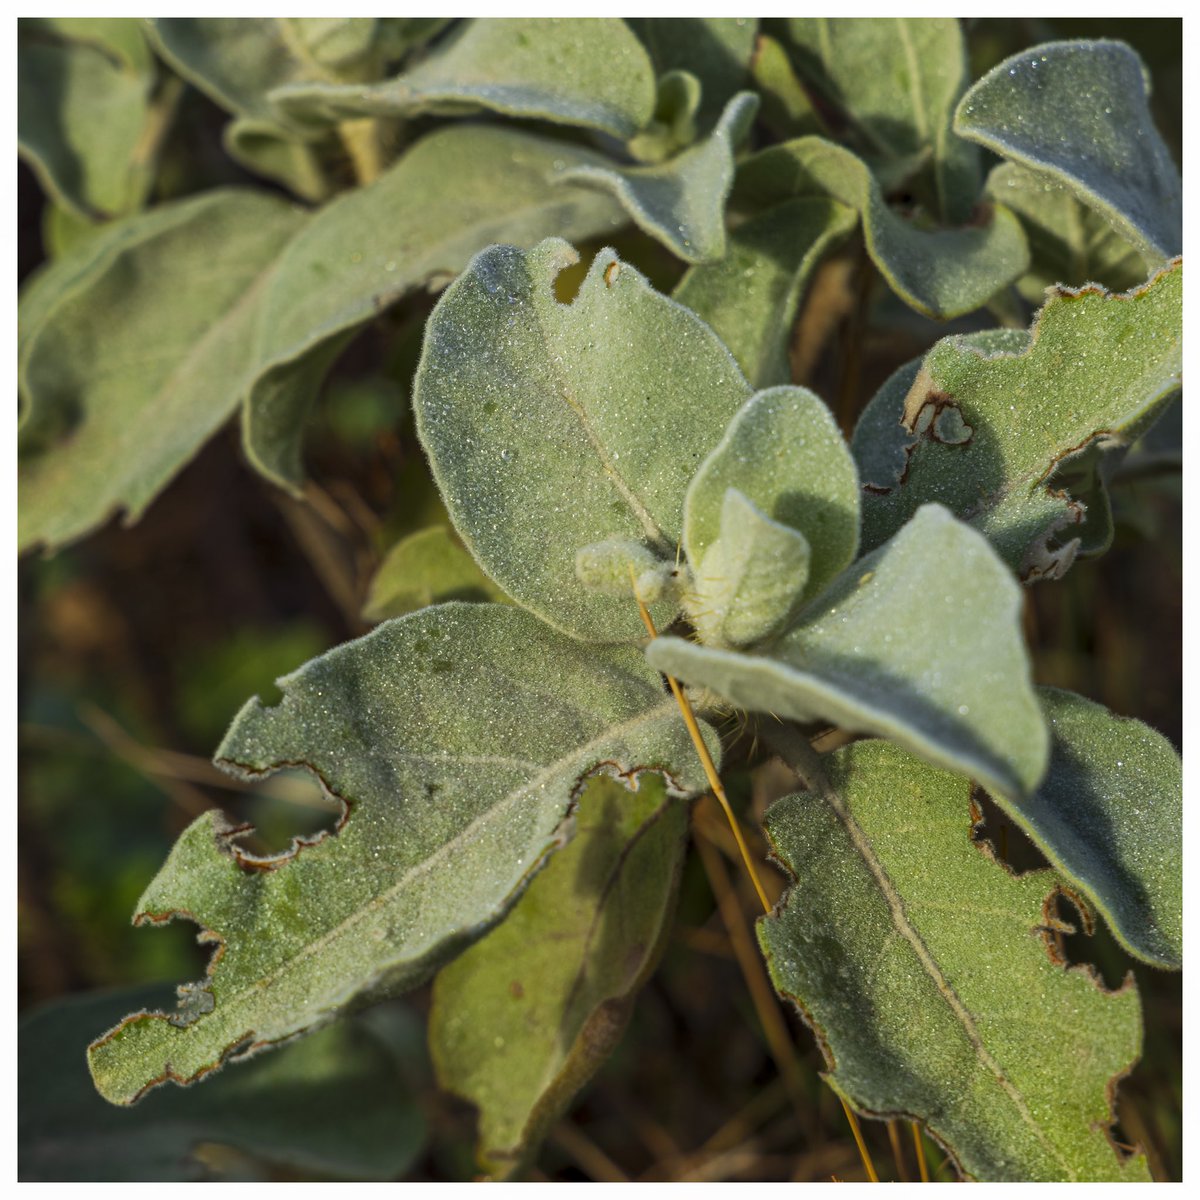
[733,137,1028,320]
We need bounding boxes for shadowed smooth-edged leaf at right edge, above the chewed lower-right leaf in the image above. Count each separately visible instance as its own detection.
[997,688,1183,967]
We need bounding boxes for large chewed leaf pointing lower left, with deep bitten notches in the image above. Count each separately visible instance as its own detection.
[90,604,703,1104]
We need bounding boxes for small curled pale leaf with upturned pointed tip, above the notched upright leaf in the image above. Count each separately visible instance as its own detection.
[560,91,758,263]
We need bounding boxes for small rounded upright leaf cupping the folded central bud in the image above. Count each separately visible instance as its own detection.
[683,388,859,598]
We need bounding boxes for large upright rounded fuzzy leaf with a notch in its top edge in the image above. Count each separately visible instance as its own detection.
[413,240,750,641]
